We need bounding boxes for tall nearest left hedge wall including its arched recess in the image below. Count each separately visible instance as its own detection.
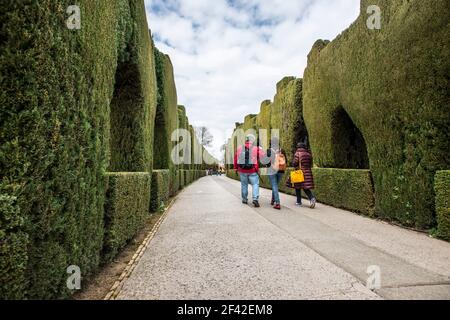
[0,0,156,299]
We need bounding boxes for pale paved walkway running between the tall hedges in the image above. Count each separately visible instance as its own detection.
[119,177,450,299]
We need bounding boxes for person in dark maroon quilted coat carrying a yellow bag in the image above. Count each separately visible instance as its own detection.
[286,143,317,209]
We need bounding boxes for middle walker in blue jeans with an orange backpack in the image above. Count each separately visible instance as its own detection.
[266,137,287,210]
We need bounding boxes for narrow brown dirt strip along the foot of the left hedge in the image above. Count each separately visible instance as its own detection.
[73,213,162,300]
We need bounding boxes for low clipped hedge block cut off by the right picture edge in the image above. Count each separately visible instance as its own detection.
[434,170,450,241]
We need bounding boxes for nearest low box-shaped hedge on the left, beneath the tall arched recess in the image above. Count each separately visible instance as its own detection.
[102,172,152,262]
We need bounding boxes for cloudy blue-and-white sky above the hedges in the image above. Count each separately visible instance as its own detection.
[145,0,360,159]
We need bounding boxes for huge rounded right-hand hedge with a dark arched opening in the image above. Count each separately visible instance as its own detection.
[303,0,450,229]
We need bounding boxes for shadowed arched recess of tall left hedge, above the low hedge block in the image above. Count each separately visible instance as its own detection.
[109,0,157,172]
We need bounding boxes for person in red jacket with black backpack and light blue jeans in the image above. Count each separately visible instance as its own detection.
[234,134,265,208]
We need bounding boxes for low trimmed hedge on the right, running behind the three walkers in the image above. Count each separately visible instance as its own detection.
[227,168,375,217]
